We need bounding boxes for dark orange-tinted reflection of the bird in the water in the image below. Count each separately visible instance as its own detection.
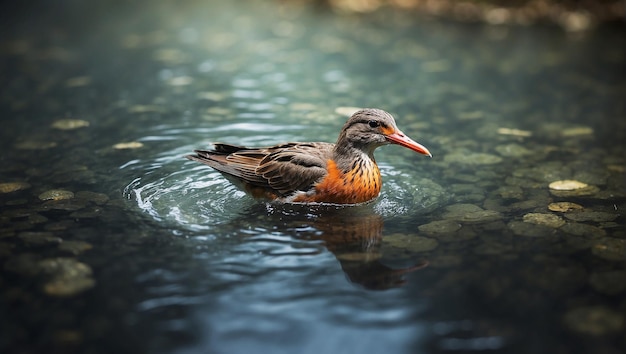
[238,204,428,290]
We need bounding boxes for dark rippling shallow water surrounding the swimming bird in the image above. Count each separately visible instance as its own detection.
[0,1,626,353]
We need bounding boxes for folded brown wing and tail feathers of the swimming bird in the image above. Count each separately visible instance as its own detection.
[186,143,334,196]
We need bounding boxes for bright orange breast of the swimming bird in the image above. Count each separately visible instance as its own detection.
[294,160,382,204]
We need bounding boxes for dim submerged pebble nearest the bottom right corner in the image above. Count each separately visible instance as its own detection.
[563,305,624,336]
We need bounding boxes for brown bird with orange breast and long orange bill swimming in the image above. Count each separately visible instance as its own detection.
[185,108,432,204]
